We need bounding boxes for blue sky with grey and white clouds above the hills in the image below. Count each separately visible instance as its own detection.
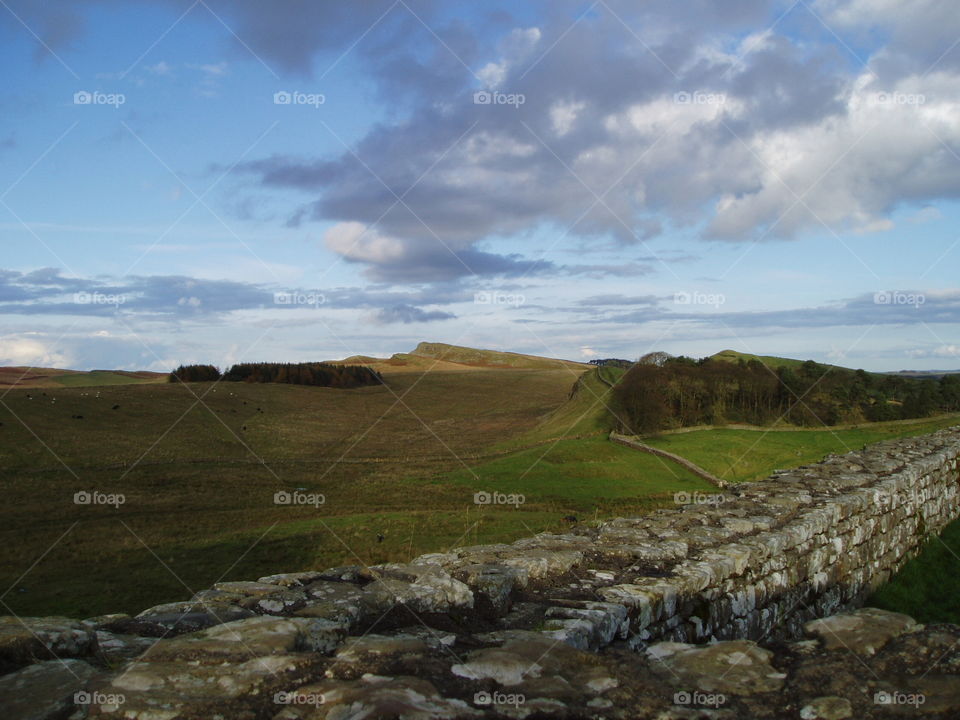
[0,0,960,370]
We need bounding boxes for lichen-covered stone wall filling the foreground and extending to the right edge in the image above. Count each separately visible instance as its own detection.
[0,428,960,720]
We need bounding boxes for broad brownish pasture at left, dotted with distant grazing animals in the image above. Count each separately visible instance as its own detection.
[0,369,600,616]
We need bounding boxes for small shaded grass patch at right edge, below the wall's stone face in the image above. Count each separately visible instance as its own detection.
[867,520,960,624]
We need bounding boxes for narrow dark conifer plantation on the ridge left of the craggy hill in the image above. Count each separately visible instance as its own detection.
[170,362,382,388]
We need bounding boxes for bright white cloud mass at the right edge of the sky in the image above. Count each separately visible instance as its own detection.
[711,74,960,237]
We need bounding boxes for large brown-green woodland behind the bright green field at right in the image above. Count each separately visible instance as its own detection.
[614,357,960,434]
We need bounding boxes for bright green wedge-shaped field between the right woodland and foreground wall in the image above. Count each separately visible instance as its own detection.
[644,416,960,482]
